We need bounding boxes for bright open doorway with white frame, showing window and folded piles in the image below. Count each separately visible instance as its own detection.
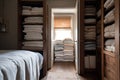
[51,8,79,73]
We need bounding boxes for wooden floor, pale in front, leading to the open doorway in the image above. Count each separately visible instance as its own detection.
[42,62,97,80]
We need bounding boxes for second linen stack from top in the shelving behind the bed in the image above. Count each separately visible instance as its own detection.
[24,17,43,23]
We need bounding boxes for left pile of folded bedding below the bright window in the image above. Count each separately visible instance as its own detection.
[54,40,64,61]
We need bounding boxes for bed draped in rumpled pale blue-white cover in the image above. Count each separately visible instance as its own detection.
[0,50,43,80]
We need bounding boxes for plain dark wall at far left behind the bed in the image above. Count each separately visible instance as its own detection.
[0,0,17,49]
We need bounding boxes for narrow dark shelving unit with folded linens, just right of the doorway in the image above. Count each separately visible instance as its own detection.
[83,0,96,73]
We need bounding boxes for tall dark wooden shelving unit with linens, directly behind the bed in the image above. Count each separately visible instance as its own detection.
[18,0,47,77]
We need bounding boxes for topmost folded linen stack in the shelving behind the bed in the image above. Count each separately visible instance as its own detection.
[22,6,43,15]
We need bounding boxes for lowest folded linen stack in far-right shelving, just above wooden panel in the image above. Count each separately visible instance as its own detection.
[105,39,115,52]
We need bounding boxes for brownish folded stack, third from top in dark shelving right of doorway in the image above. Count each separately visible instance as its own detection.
[85,26,96,40]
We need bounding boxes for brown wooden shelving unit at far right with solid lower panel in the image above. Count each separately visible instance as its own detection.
[101,0,120,80]
